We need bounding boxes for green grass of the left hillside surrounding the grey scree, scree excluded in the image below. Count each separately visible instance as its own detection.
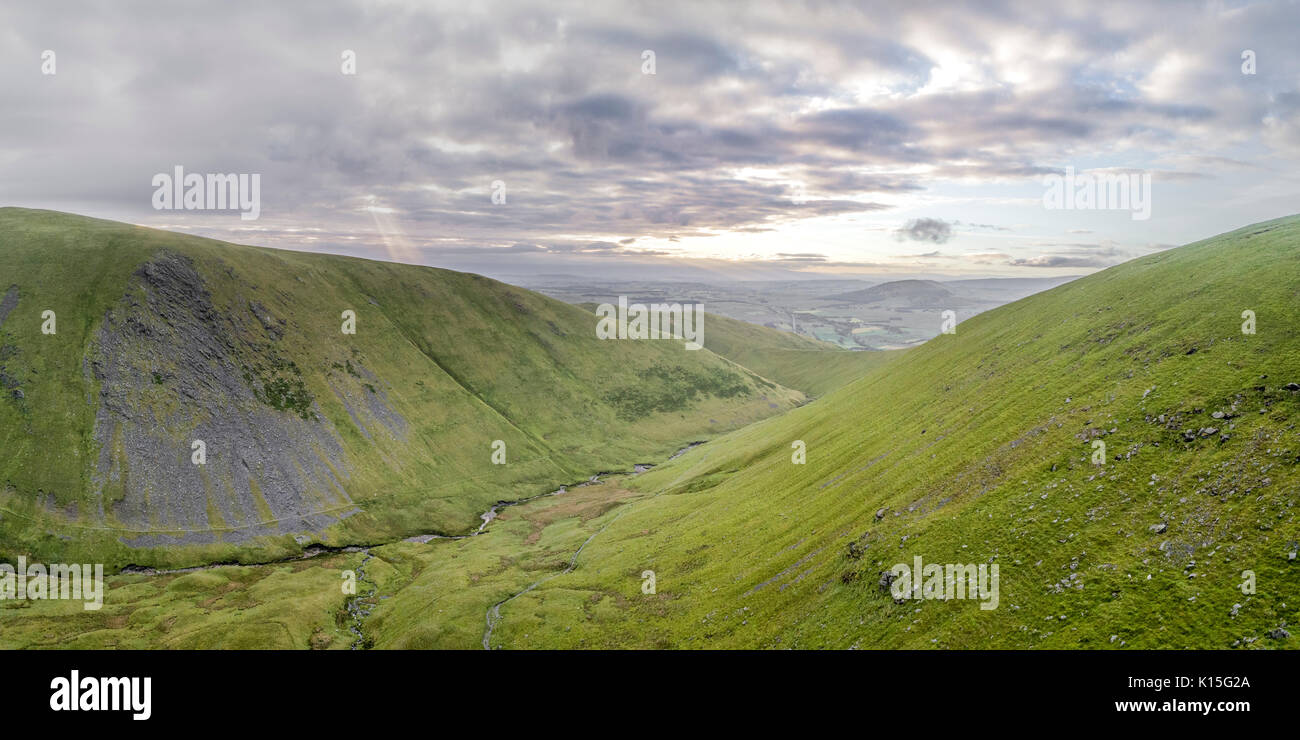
[0,208,802,570]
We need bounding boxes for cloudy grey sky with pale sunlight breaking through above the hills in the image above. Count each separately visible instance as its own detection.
[0,0,1300,280]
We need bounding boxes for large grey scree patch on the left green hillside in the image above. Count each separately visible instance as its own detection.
[86,252,356,546]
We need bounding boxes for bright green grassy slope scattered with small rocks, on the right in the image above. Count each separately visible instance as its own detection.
[441,211,1300,648]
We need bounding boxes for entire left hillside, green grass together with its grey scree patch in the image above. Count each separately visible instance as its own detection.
[0,208,803,570]
